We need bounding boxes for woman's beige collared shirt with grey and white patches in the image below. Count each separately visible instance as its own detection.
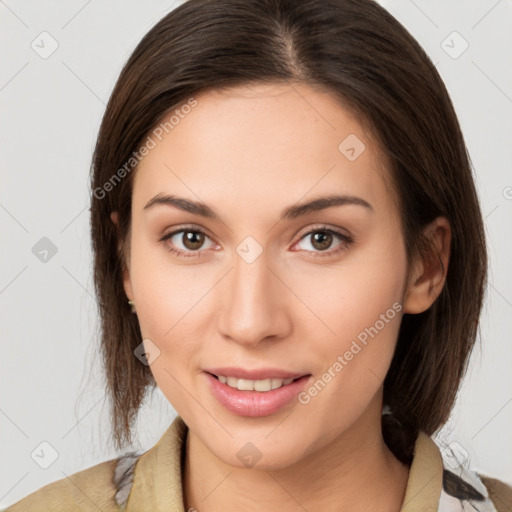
[6,416,512,512]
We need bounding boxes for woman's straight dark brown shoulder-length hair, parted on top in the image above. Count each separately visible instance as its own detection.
[91,0,487,462]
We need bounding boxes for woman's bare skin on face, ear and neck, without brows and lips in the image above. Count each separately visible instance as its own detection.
[112,84,450,512]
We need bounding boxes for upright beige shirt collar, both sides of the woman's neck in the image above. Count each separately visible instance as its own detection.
[126,416,443,512]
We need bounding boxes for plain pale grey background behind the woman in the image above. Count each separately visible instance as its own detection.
[0,0,512,507]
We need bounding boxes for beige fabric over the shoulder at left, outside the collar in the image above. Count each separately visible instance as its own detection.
[4,452,139,512]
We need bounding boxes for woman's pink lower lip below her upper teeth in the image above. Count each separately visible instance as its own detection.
[205,372,310,418]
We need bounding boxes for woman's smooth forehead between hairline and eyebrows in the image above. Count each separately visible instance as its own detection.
[133,84,390,216]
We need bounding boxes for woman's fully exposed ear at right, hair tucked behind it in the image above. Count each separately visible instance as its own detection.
[403,217,451,314]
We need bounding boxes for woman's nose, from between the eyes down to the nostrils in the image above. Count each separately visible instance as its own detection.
[219,239,285,344]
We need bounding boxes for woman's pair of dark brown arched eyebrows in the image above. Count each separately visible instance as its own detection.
[144,194,374,221]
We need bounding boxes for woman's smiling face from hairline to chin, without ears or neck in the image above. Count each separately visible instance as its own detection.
[124,84,414,468]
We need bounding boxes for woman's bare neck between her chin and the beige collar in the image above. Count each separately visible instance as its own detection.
[184,400,409,512]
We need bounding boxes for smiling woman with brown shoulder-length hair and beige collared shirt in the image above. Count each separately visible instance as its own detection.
[8,0,512,512]
